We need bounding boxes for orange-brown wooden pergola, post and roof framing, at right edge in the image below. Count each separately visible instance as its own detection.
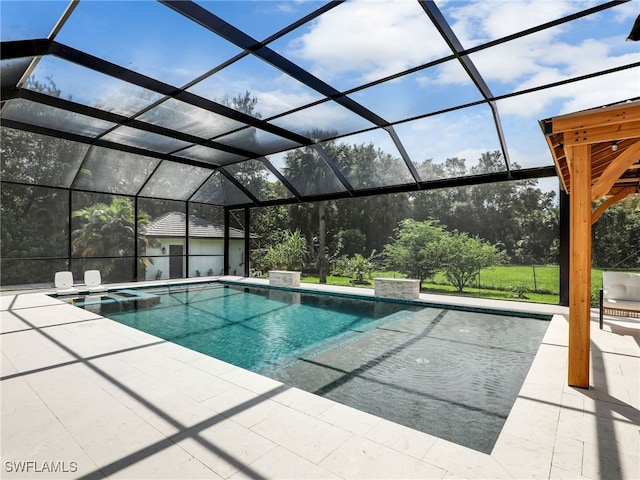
[540,100,640,388]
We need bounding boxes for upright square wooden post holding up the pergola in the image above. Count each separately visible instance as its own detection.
[565,144,591,388]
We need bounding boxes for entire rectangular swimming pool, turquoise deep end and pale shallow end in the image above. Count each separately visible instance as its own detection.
[71,283,548,453]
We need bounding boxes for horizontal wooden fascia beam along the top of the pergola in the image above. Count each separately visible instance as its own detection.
[552,101,640,133]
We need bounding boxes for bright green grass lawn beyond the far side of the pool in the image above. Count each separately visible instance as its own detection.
[301,265,636,305]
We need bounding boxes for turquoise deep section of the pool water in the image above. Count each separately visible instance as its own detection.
[75,284,419,371]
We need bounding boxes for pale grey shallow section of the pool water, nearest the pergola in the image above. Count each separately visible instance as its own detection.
[268,308,549,454]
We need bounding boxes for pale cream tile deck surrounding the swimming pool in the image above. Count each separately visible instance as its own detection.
[0,277,640,480]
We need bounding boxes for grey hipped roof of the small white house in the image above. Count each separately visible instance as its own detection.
[144,212,250,238]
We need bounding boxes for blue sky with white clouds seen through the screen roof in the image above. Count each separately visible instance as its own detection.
[0,0,640,197]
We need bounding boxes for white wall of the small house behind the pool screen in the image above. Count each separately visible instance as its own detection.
[144,237,244,280]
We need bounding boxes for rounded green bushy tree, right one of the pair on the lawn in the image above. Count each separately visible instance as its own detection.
[438,231,508,292]
